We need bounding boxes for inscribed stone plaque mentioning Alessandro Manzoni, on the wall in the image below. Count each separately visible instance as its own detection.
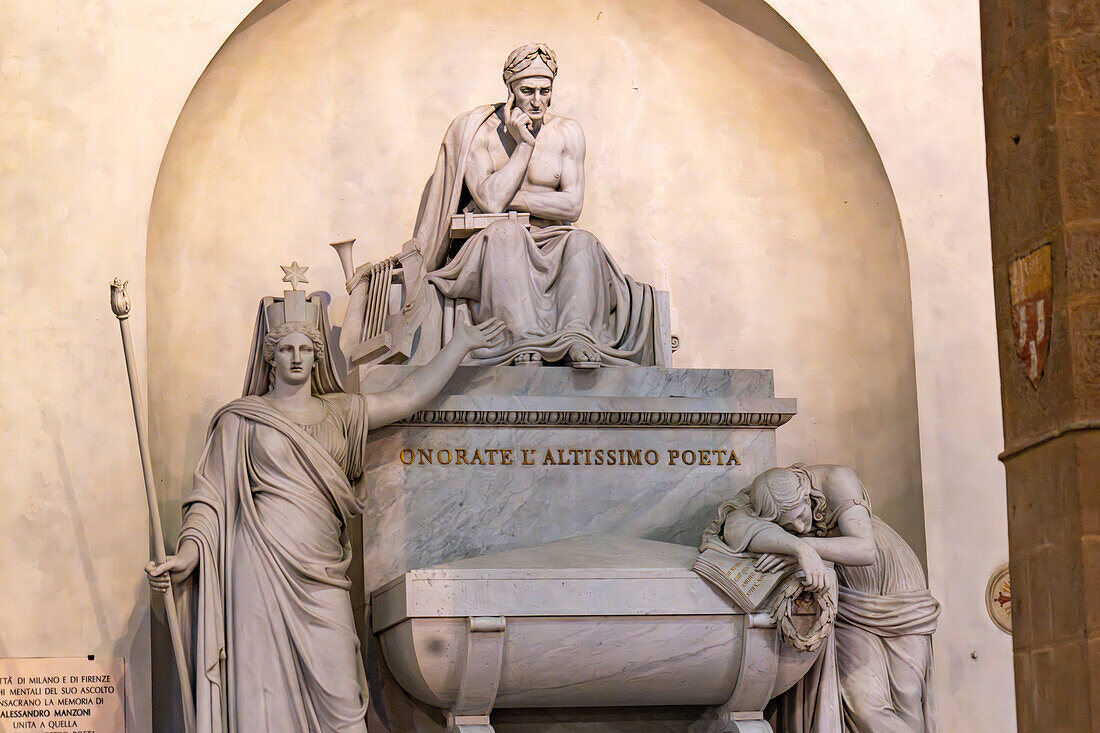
[0,657,125,733]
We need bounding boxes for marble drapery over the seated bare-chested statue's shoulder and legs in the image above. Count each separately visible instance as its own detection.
[415,105,653,365]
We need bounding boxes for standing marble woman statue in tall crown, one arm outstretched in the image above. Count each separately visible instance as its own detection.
[146,293,504,733]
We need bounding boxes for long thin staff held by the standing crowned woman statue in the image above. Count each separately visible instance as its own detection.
[111,277,195,733]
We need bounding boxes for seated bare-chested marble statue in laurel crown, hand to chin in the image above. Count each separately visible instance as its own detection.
[349,44,655,367]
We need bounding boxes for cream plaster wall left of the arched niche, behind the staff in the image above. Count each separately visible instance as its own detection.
[0,0,248,732]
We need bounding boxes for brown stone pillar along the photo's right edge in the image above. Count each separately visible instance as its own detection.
[985,0,1100,731]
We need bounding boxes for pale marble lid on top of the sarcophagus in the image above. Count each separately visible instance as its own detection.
[372,535,741,633]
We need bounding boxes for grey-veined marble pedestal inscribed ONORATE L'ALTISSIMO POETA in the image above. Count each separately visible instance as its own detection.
[361,367,795,731]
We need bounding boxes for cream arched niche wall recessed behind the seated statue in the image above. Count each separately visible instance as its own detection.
[147,0,924,556]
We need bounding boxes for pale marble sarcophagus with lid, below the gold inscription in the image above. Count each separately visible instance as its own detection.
[372,535,820,733]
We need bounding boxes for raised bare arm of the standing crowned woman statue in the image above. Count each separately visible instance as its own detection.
[366,318,505,430]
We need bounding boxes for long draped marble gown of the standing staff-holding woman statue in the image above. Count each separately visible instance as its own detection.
[179,394,367,733]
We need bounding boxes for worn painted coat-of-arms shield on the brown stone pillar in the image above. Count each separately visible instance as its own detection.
[1009,244,1053,387]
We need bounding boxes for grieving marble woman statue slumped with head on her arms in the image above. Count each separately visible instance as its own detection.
[703,463,939,733]
